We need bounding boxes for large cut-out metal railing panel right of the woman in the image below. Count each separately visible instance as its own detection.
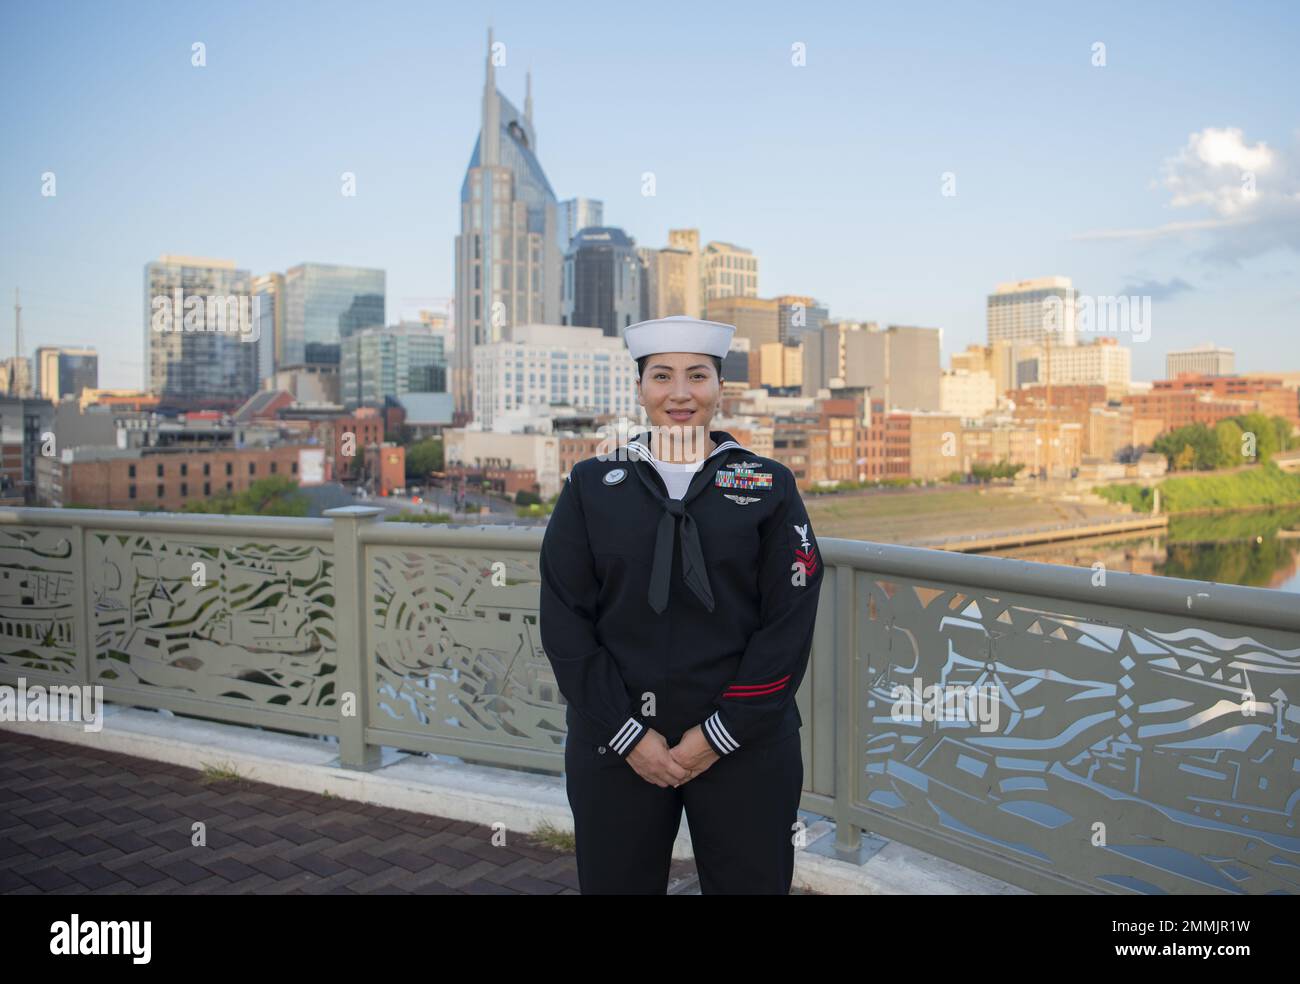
[857,578,1300,893]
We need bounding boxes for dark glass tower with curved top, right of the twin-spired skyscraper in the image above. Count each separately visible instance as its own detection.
[562,226,649,338]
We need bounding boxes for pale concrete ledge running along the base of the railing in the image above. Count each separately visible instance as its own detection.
[0,705,1031,894]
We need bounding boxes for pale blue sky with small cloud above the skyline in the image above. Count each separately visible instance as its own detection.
[0,0,1300,386]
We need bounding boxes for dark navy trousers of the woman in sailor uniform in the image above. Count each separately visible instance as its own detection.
[564,732,803,896]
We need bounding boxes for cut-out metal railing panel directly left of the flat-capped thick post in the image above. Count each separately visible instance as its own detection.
[86,532,338,718]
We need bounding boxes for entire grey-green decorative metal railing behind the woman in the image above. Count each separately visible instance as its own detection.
[0,507,1300,893]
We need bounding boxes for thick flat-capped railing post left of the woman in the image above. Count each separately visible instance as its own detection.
[324,506,384,770]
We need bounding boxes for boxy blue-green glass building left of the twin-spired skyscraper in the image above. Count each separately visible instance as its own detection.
[278,263,385,368]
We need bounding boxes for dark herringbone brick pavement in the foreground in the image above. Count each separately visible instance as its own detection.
[0,731,813,896]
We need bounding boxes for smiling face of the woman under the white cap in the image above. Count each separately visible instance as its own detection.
[637,352,723,461]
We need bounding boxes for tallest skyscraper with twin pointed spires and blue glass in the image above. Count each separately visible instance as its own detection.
[451,30,563,420]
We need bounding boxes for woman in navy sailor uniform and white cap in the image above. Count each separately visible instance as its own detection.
[540,317,823,894]
